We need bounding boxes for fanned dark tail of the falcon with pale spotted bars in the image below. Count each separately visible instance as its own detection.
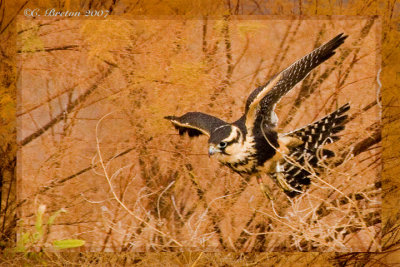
[273,103,350,197]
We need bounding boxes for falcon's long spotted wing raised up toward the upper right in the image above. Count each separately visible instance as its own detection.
[245,33,347,129]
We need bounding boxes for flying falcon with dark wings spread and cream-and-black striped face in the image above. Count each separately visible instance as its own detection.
[165,33,350,199]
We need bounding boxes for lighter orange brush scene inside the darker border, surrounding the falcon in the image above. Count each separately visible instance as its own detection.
[17,17,381,252]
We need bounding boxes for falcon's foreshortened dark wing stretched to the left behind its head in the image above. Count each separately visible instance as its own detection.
[164,112,228,137]
